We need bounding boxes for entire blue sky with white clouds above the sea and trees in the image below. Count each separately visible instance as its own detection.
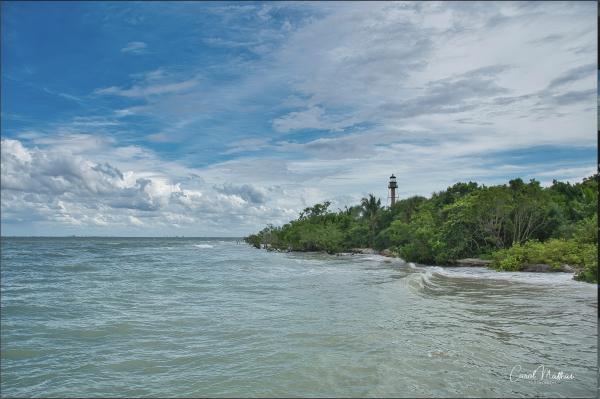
[0,1,598,236]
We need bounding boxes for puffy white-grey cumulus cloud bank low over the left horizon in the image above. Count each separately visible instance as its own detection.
[1,139,298,236]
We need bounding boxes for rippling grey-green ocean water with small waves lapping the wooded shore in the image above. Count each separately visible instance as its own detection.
[0,238,598,397]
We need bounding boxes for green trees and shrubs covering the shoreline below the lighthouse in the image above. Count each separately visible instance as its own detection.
[245,175,598,282]
